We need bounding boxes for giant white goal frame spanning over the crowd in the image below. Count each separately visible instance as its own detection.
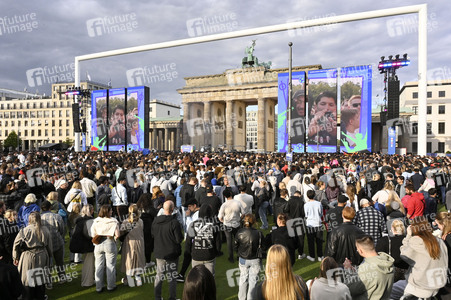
[75,4,427,155]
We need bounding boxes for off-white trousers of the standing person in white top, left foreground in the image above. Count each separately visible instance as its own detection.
[94,238,117,291]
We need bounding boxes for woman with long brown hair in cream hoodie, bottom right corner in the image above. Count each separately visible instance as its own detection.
[390,216,448,299]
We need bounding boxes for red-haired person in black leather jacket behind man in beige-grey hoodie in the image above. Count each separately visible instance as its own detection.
[326,207,364,266]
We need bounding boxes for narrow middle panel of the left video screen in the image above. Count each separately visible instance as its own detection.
[108,88,126,151]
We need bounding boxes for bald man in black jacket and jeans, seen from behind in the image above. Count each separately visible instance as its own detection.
[152,200,183,299]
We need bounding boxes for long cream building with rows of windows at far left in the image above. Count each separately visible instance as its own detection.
[0,82,108,150]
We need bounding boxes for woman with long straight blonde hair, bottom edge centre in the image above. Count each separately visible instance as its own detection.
[257,244,308,300]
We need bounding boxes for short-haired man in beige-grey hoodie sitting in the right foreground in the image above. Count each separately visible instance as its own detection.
[343,235,394,300]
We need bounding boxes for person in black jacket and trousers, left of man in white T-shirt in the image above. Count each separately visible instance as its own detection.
[284,191,306,259]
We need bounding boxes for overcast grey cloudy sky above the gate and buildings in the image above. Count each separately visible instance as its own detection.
[0,0,451,108]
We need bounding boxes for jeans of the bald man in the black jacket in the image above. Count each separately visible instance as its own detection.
[155,258,179,300]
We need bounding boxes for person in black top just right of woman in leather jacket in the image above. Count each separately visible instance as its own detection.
[265,214,298,265]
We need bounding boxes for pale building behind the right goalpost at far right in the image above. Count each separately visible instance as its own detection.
[400,80,451,153]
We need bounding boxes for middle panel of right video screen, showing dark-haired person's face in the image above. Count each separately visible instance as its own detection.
[307,69,337,153]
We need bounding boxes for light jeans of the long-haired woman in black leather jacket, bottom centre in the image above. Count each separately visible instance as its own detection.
[238,257,260,300]
